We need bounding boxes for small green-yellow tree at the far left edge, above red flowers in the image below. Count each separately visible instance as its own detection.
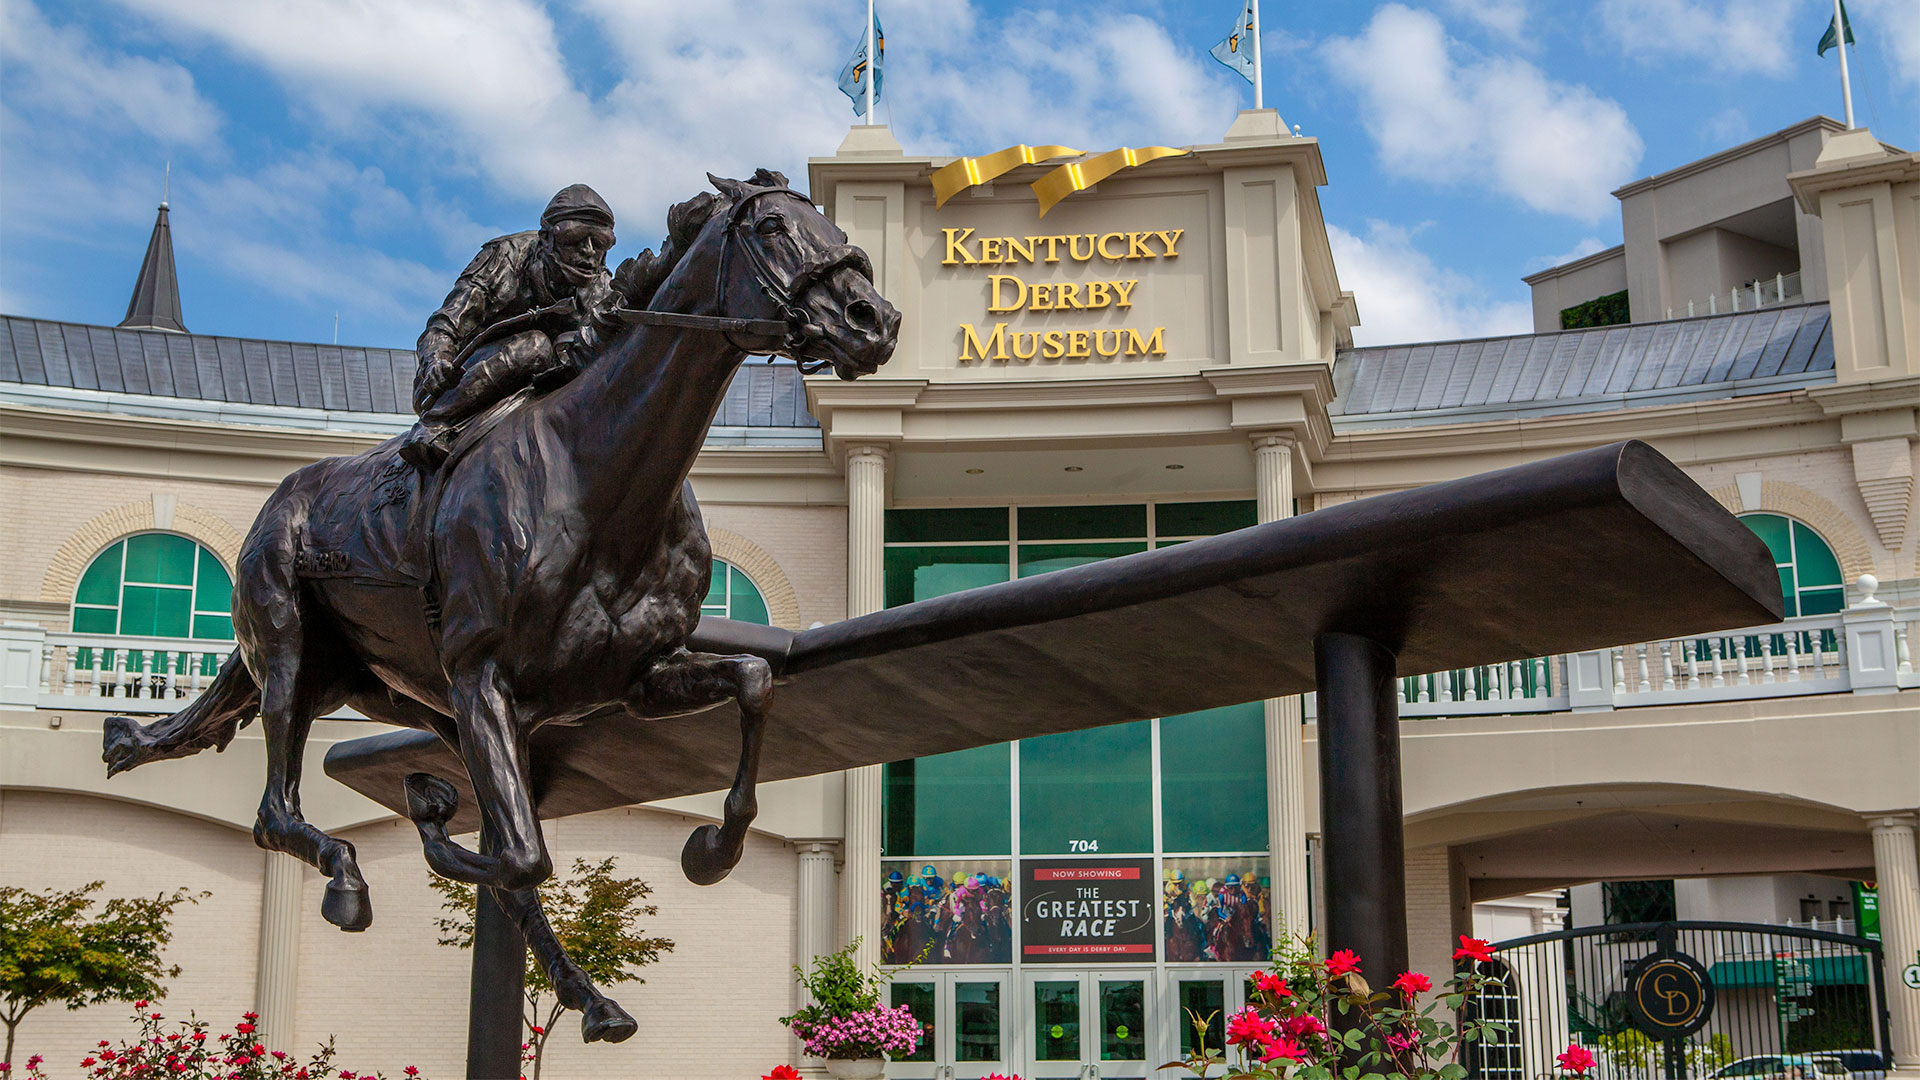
[0,882,209,1063]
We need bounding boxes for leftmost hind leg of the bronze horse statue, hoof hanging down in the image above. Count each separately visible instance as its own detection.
[244,555,372,930]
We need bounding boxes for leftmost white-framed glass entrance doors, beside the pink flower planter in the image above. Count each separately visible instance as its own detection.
[887,970,1012,1080]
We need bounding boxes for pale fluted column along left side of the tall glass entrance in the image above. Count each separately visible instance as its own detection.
[841,446,887,970]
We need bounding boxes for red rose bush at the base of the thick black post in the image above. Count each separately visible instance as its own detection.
[1162,936,1594,1080]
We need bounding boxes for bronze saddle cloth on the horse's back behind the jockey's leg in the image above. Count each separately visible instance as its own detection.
[294,386,538,588]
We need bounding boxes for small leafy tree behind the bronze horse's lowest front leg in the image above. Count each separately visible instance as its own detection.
[428,859,674,1080]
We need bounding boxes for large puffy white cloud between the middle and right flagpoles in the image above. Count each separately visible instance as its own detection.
[1323,4,1642,221]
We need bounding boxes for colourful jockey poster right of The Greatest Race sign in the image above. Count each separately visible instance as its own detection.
[1160,855,1273,963]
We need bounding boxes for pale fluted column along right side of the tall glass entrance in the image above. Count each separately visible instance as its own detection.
[1254,432,1311,936]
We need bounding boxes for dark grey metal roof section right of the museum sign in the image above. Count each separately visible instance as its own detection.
[1331,304,1834,421]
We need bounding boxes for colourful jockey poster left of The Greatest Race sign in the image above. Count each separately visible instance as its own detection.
[879,859,1014,965]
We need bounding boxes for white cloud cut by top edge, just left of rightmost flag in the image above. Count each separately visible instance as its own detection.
[1599,0,1804,75]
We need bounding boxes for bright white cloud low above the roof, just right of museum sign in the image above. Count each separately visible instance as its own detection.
[1327,221,1534,344]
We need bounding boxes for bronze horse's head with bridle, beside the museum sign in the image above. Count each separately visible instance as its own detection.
[703,169,900,380]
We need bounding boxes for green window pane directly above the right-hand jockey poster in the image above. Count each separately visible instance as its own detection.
[1160,701,1267,851]
